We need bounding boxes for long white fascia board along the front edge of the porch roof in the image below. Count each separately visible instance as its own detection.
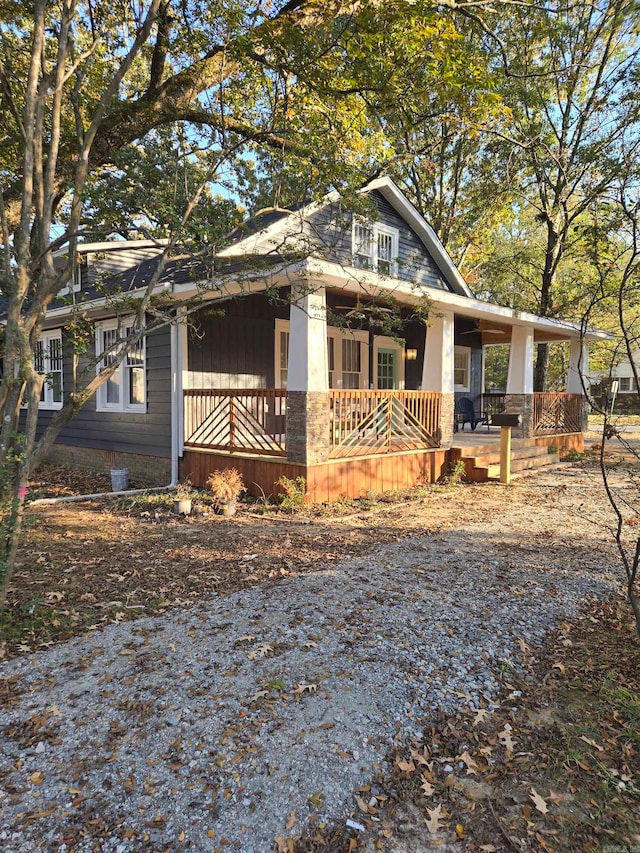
[307,258,615,341]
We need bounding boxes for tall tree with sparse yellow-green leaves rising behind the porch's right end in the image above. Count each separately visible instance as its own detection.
[482,0,640,390]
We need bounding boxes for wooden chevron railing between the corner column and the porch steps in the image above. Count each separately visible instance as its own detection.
[329,390,440,459]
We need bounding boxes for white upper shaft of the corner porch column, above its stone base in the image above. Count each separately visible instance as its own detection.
[287,287,329,393]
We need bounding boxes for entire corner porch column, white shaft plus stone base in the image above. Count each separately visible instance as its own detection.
[287,283,329,465]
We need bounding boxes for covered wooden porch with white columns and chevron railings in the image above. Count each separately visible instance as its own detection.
[182,287,588,500]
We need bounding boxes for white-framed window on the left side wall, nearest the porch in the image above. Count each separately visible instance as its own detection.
[96,319,147,412]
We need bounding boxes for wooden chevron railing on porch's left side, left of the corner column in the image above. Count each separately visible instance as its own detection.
[184,388,287,456]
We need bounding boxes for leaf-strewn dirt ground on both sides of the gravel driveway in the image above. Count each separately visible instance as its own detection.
[0,433,640,853]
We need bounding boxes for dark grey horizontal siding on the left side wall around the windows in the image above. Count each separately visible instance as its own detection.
[32,327,171,459]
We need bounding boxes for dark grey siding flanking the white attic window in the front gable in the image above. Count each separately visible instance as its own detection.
[311,191,447,290]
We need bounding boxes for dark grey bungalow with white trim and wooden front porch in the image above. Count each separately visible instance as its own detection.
[30,177,602,500]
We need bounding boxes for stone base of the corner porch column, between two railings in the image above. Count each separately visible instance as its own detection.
[287,391,330,465]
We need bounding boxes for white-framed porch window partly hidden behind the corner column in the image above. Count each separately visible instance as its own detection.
[274,320,369,388]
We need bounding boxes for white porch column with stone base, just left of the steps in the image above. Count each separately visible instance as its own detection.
[421,311,455,447]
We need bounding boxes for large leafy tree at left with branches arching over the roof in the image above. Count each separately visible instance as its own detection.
[0,0,484,604]
